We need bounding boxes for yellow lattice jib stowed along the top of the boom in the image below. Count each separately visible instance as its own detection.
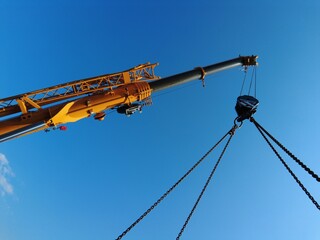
[0,63,159,117]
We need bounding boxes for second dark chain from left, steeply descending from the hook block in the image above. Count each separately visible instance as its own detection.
[176,125,236,240]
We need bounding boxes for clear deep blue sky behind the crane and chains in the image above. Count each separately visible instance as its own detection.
[0,0,320,240]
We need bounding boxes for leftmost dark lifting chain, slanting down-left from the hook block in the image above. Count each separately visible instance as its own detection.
[116,124,234,240]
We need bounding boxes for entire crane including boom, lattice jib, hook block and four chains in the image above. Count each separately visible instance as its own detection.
[0,55,320,240]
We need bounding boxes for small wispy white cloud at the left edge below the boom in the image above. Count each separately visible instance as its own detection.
[0,153,14,196]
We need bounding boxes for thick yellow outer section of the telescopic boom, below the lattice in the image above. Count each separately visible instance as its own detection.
[0,81,151,136]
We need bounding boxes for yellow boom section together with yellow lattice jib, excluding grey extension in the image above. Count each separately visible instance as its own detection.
[0,63,159,141]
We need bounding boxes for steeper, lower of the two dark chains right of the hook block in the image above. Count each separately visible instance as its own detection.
[251,118,320,210]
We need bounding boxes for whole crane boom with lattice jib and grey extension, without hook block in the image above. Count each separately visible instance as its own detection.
[0,55,257,142]
